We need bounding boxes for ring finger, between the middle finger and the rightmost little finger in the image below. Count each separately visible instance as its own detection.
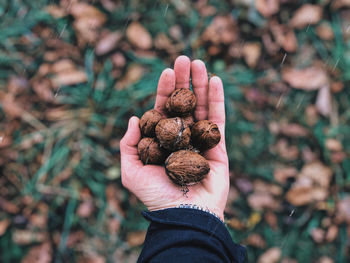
[191,59,208,121]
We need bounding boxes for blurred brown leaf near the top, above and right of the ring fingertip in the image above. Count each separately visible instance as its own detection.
[202,15,238,45]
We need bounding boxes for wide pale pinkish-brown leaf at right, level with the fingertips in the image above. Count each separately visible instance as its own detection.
[282,67,329,91]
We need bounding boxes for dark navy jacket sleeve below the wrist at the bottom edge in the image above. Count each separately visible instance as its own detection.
[137,208,246,263]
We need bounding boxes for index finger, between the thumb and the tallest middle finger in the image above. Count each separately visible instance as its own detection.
[154,68,175,113]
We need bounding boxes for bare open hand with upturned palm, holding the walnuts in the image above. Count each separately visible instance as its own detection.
[120,56,230,223]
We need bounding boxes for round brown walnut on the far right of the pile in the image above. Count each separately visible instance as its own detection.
[191,120,221,150]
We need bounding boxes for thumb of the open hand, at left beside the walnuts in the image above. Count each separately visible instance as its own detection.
[120,116,143,180]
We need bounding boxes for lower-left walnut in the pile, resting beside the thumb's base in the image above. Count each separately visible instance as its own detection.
[137,137,166,164]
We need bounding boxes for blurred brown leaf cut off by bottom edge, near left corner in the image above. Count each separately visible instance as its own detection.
[21,242,52,263]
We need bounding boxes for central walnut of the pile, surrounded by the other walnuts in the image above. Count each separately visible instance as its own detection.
[156,117,191,151]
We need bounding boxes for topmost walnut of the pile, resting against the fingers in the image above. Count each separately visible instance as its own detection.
[165,89,197,116]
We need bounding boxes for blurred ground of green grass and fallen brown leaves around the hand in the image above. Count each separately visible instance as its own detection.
[0,0,350,263]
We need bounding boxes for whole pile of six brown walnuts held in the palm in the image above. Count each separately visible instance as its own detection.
[138,89,221,187]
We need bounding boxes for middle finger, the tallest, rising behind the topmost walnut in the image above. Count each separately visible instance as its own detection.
[174,56,191,89]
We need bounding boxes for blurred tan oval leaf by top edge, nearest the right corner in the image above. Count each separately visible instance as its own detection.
[290,4,323,29]
